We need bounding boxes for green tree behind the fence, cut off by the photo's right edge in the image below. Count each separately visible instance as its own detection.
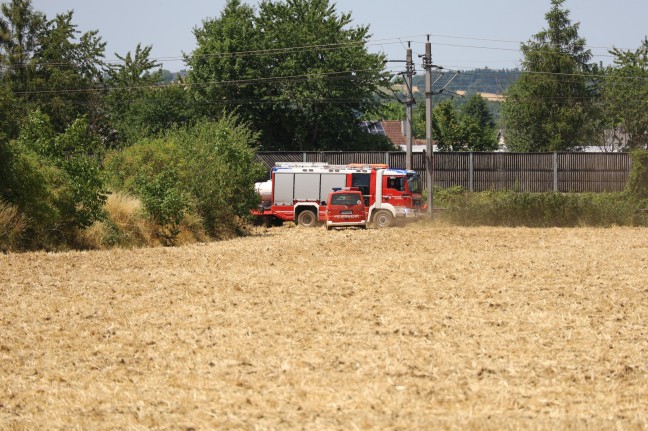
[602,38,648,149]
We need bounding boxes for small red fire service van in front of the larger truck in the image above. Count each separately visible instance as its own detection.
[326,187,367,230]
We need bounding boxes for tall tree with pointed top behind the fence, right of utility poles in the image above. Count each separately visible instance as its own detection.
[502,0,595,151]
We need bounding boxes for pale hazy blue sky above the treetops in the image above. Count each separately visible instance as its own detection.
[27,0,648,71]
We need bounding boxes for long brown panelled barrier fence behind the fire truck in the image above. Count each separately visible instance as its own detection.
[256,151,631,192]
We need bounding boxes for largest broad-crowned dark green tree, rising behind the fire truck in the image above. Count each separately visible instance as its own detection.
[187,0,387,150]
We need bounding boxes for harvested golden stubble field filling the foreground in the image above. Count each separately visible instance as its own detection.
[0,222,648,430]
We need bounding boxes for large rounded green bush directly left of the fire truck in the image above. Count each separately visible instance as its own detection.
[107,117,265,238]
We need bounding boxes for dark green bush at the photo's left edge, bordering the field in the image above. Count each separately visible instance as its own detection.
[0,111,105,249]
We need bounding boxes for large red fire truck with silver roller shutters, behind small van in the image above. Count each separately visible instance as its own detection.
[252,162,423,227]
